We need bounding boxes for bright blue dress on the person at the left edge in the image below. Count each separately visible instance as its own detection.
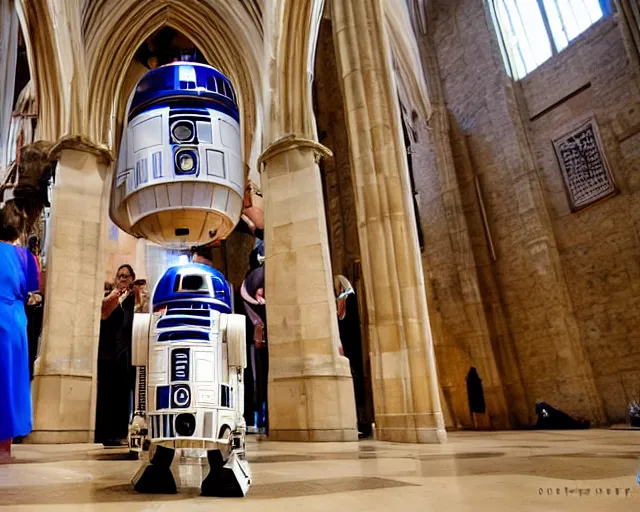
[0,242,39,441]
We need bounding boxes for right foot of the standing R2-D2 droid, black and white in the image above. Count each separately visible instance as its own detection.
[201,450,251,498]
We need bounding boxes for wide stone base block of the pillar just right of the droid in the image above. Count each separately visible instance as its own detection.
[269,376,358,442]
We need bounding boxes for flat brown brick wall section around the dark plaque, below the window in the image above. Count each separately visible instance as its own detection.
[521,16,640,422]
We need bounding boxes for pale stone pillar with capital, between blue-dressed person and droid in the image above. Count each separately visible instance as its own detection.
[28,139,110,443]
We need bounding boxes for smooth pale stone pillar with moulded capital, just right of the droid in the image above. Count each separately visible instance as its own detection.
[260,136,358,441]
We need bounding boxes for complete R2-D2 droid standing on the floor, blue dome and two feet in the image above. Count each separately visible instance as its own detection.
[129,264,251,496]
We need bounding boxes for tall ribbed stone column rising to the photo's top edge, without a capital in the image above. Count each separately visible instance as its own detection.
[332,0,446,443]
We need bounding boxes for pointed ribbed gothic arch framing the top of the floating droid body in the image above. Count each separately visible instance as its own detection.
[83,0,261,162]
